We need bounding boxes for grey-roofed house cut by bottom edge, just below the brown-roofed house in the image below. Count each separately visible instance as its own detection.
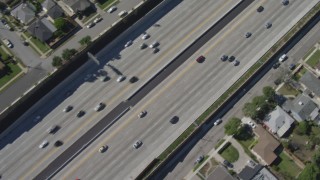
[238,164,278,180]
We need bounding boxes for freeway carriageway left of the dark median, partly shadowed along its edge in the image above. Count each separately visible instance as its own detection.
[0,0,238,179]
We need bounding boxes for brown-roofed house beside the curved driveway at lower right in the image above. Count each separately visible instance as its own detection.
[252,125,280,165]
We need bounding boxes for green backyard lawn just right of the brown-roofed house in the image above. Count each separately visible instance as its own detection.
[276,151,301,179]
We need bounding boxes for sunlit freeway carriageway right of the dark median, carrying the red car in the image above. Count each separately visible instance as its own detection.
[53,1,317,179]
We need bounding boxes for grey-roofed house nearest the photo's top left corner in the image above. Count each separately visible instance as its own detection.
[11,3,35,24]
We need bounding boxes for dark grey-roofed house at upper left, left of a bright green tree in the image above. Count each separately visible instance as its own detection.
[27,18,57,42]
